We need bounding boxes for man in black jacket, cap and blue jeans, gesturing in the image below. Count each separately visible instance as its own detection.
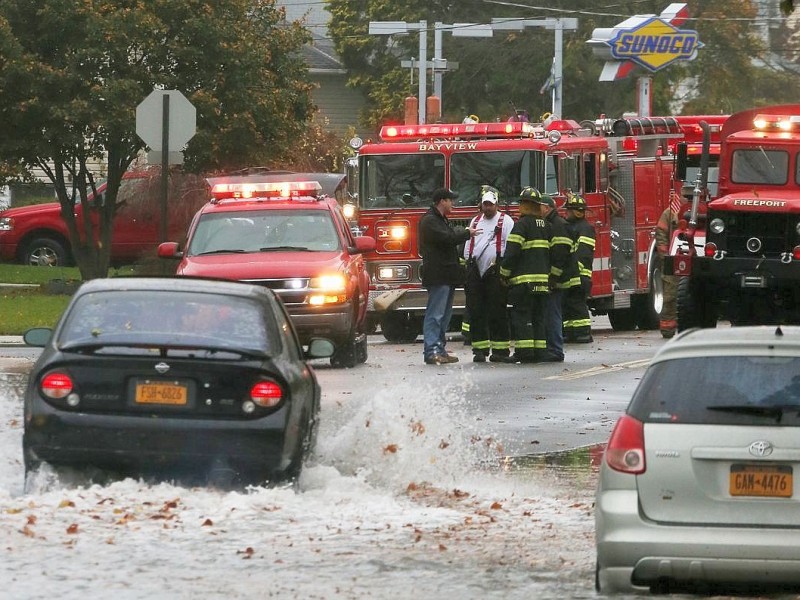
[419,188,478,365]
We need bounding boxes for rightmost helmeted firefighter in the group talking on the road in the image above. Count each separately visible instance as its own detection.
[562,194,595,344]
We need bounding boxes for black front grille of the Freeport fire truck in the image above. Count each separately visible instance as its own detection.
[709,213,800,258]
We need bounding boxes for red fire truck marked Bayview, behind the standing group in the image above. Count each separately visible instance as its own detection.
[351,117,683,342]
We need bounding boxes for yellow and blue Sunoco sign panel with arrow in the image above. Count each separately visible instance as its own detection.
[607,18,703,71]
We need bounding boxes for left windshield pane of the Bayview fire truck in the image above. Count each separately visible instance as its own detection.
[359,154,444,208]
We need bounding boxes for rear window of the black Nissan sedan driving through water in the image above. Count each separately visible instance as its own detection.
[57,290,280,355]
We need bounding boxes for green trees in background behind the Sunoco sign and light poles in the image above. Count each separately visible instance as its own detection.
[327,0,800,127]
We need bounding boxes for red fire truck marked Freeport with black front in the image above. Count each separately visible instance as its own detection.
[672,104,800,330]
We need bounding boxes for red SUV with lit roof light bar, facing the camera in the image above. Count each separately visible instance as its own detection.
[158,175,375,367]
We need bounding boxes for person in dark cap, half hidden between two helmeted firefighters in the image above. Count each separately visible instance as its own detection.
[540,194,581,362]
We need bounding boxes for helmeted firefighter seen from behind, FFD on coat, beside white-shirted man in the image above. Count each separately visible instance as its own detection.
[500,187,551,363]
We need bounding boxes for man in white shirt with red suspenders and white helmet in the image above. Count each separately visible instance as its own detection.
[464,186,514,362]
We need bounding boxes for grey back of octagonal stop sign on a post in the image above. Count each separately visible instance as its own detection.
[136,90,197,152]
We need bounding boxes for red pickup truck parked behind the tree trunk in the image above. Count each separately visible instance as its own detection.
[0,172,208,266]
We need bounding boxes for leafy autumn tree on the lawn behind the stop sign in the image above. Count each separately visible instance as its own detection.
[0,0,312,279]
